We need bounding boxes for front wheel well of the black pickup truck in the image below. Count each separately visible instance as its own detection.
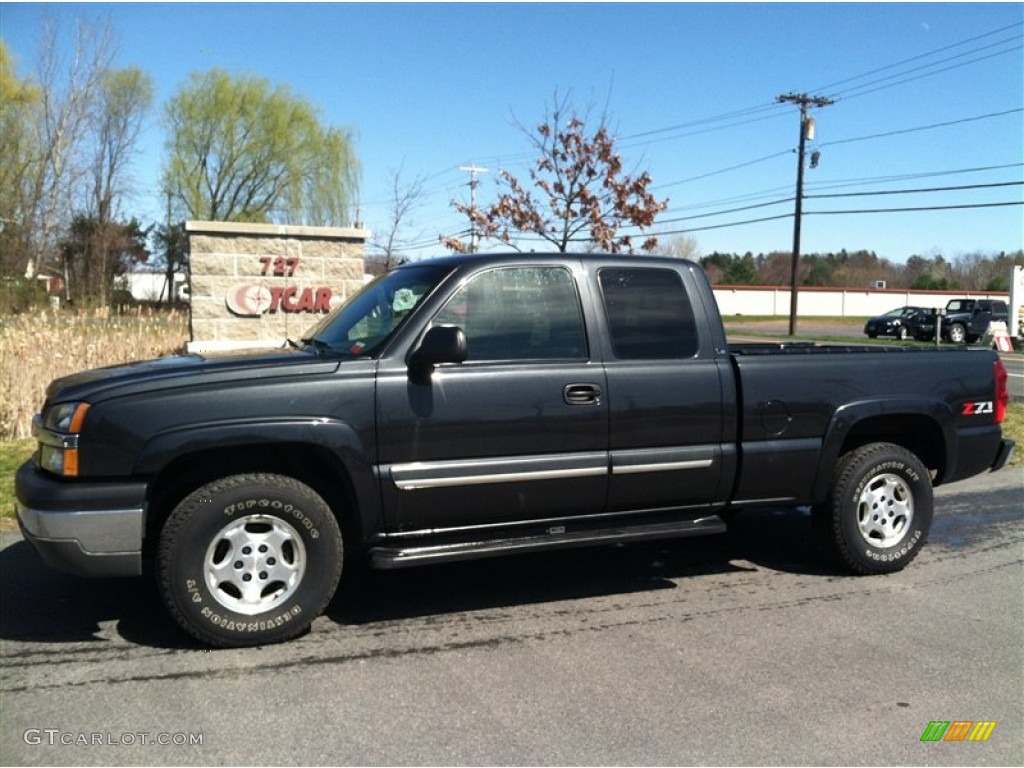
[142,442,361,559]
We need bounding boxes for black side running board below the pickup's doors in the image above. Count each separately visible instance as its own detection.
[370,515,726,570]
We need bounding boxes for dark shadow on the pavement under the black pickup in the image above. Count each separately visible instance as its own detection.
[0,510,841,649]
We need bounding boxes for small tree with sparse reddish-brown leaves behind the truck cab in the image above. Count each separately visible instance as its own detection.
[442,99,668,253]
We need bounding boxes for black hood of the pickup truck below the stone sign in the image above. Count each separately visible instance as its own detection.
[46,349,339,402]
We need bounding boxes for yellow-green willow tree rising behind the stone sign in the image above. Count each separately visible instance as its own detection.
[164,69,358,225]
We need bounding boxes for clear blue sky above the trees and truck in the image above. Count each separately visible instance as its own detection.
[0,3,1024,262]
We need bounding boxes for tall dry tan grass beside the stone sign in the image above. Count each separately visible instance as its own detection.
[0,309,188,440]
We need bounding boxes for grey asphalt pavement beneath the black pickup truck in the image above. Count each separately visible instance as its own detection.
[0,470,1024,766]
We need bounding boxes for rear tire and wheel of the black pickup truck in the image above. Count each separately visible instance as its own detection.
[813,442,933,575]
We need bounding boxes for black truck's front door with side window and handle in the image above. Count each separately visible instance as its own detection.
[377,263,608,532]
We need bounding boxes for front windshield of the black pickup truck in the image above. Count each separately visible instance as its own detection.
[302,265,449,357]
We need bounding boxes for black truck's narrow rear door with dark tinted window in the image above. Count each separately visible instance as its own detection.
[597,265,734,516]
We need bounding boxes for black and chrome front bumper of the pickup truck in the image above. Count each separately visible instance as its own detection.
[14,461,145,577]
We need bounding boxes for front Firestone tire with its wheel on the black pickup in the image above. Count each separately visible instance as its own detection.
[157,474,342,648]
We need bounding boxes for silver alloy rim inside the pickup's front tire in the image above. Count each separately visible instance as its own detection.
[204,515,306,616]
